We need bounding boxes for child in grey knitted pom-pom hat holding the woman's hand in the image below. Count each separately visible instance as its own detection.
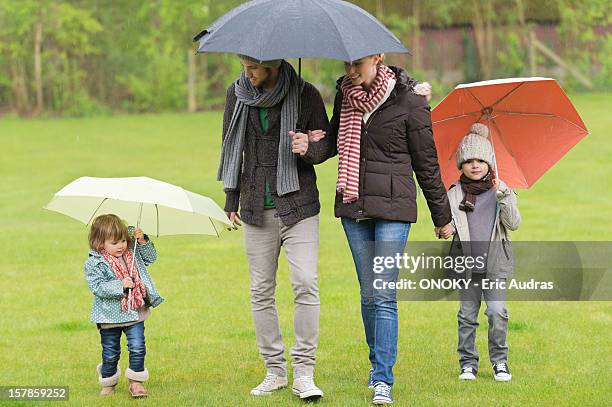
[442,123,521,381]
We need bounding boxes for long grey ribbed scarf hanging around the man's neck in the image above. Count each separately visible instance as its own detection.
[217,61,303,196]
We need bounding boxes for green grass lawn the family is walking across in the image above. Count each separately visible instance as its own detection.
[0,94,612,406]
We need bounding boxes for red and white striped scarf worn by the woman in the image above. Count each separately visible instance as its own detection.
[336,65,395,203]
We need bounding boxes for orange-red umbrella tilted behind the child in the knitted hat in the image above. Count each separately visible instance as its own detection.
[431,78,588,188]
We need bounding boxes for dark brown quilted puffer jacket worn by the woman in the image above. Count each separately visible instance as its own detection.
[324,66,451,226]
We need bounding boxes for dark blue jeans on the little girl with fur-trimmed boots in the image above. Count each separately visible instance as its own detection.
[100,322,147,377]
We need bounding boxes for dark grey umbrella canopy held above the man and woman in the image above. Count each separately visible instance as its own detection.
[194,0,409,62]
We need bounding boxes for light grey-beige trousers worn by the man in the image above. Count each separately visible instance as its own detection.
[244,209,320,377]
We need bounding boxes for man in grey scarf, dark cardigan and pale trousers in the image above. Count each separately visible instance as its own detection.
[218,55,329,400]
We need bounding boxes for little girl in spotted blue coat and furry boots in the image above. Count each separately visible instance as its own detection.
[85,215,164,398]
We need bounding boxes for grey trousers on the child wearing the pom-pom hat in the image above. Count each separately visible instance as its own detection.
[457,273,508,370]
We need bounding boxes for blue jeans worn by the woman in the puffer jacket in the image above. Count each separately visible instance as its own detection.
[342,218,410,385]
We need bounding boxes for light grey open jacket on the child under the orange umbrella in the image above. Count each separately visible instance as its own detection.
[448,180,521,278]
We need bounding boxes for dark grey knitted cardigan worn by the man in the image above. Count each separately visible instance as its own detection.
[223,82,330,226]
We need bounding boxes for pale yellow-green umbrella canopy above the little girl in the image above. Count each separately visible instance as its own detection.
[45,177,233,236]
